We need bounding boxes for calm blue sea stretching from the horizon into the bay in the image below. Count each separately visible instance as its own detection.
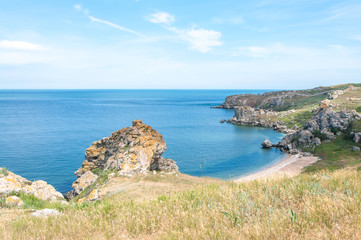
[0,90,285,193]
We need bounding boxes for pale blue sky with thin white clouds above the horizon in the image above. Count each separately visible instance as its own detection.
[0,0,361,89]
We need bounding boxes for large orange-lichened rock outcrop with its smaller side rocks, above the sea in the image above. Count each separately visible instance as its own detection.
[66,120,178,198]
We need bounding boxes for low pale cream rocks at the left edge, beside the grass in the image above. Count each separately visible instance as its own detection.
[0,171,64,201]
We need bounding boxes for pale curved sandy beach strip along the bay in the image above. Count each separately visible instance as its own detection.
[233,155,318,182]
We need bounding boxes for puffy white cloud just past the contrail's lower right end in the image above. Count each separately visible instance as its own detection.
[181,29,223,53]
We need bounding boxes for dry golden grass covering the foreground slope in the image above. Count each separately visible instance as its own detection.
[0,170,361,239]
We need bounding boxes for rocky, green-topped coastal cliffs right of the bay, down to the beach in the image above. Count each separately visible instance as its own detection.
[221,84,361,169]
